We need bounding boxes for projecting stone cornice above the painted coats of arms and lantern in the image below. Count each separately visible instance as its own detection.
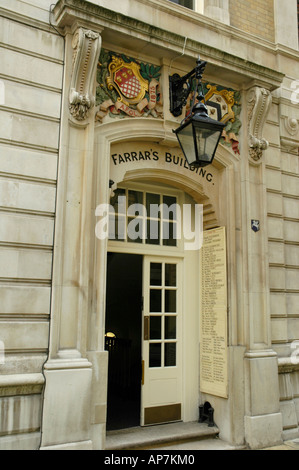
[53,0,284,90]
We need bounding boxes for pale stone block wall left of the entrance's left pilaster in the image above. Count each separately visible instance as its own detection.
[0,0,64,449]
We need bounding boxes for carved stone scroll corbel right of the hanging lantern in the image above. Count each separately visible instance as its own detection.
[247,87,272,163]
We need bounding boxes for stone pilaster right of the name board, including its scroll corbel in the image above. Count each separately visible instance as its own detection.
[242,86,282,448]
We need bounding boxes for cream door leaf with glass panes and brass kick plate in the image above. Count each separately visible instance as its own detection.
[141,256,182,426]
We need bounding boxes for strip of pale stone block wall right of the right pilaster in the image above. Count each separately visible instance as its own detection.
[266,79,299,438]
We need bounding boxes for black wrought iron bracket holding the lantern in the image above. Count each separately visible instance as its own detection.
[169,58,207,117]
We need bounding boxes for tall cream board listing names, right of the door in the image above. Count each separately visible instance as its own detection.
[200,227,228,398]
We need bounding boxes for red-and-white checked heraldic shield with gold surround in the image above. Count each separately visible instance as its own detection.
[107,56,148,106]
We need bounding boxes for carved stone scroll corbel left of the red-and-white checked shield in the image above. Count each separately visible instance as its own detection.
[69,28,101,121]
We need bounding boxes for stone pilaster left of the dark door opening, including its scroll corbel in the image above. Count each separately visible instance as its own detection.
[41,23,101,450]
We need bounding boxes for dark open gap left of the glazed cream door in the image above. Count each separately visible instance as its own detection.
[105,253,143,430]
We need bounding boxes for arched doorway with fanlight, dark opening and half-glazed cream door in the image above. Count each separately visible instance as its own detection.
[105,177,213,429]
